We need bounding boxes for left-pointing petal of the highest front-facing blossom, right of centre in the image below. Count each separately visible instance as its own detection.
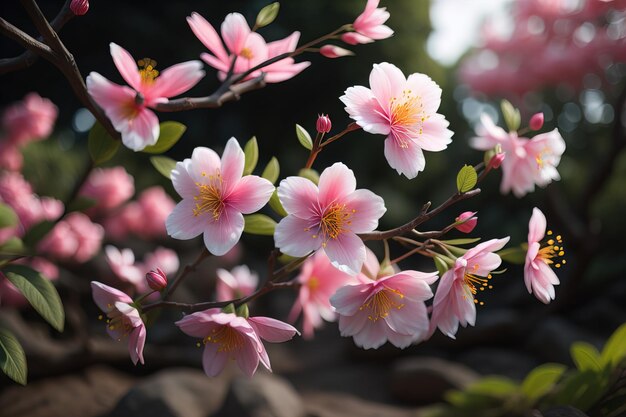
[339,85,391,135]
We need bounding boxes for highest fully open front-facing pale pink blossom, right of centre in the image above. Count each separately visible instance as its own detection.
[340,62,452,178]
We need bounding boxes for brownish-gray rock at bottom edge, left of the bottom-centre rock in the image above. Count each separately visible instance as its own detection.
[109,368,229,417]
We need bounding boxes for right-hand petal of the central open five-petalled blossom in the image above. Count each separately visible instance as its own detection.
[344,189,387,233]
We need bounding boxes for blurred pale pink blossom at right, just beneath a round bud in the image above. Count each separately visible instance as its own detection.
[470,114,565,197]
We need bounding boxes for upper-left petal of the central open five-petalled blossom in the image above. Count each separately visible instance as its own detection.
[277,177,319,218]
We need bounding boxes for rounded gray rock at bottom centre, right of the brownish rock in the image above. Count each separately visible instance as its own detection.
[215,373,305,417]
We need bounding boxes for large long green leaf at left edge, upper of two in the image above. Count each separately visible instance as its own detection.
[2,265,65,332]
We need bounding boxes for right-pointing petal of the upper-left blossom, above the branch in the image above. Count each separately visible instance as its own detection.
[150,61,204,97]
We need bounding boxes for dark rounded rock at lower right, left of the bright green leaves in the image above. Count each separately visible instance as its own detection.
[390,357,479,405]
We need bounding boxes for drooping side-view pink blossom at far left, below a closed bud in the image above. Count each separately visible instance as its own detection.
[91,281,146,365]
